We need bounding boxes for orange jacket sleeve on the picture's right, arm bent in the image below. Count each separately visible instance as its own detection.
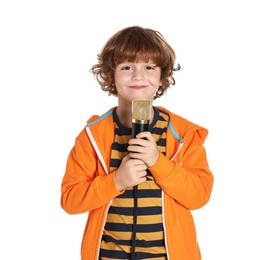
[150,129,213,210]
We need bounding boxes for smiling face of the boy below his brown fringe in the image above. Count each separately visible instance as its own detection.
[114,62,161,102]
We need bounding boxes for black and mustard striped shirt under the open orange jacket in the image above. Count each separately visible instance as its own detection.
[100,108,169,260]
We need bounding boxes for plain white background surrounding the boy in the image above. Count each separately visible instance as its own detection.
[0,0,279,260]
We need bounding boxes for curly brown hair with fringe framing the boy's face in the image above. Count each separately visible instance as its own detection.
[90,26,180,99]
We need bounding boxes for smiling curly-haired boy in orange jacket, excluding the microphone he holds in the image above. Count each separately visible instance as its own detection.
[61,26,213,260]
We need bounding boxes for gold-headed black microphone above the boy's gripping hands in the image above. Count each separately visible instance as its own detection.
[132,99,152,138]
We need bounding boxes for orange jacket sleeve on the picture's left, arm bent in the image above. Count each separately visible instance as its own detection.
[61,131,123,214]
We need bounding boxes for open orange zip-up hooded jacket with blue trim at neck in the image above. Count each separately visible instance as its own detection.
[61,107,213,260]
